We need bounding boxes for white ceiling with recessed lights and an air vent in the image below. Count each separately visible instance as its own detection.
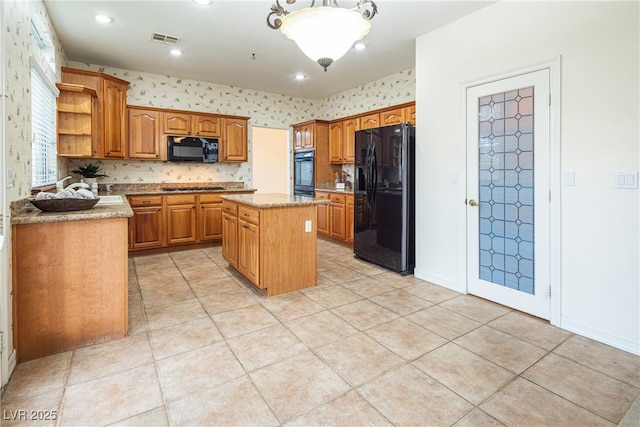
[44,0,494,99]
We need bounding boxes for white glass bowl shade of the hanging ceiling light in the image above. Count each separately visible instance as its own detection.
[280,7,371,71]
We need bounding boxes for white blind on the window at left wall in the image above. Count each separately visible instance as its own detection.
[31,67,58,187]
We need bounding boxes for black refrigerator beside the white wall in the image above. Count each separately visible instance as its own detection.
[353,124,415,274]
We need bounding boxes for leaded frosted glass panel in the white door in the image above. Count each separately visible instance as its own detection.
[478,87,535,294]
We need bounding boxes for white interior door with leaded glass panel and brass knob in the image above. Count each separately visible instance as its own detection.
[466,69,550,319]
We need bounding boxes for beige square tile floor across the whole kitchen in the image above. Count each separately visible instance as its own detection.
[2,240,640,426]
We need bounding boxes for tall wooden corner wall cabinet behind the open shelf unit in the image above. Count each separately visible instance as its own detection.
[59,67,129,159]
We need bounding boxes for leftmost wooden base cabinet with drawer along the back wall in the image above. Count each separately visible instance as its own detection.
[128,195,165,249]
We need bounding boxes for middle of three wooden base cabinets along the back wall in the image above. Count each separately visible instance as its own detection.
[165,194,196,245]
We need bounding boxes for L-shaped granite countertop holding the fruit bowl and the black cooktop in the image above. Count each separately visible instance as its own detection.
[11,182,256,224]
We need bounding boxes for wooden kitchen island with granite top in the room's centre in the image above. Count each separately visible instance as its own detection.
[222,194,329,296]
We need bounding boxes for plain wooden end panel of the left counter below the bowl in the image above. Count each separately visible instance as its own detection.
[12,217,128,362]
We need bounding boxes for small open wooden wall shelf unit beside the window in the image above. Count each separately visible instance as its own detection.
[56,83,98,157]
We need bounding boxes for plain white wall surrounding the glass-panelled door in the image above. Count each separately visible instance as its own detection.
[416,1,640,354]
